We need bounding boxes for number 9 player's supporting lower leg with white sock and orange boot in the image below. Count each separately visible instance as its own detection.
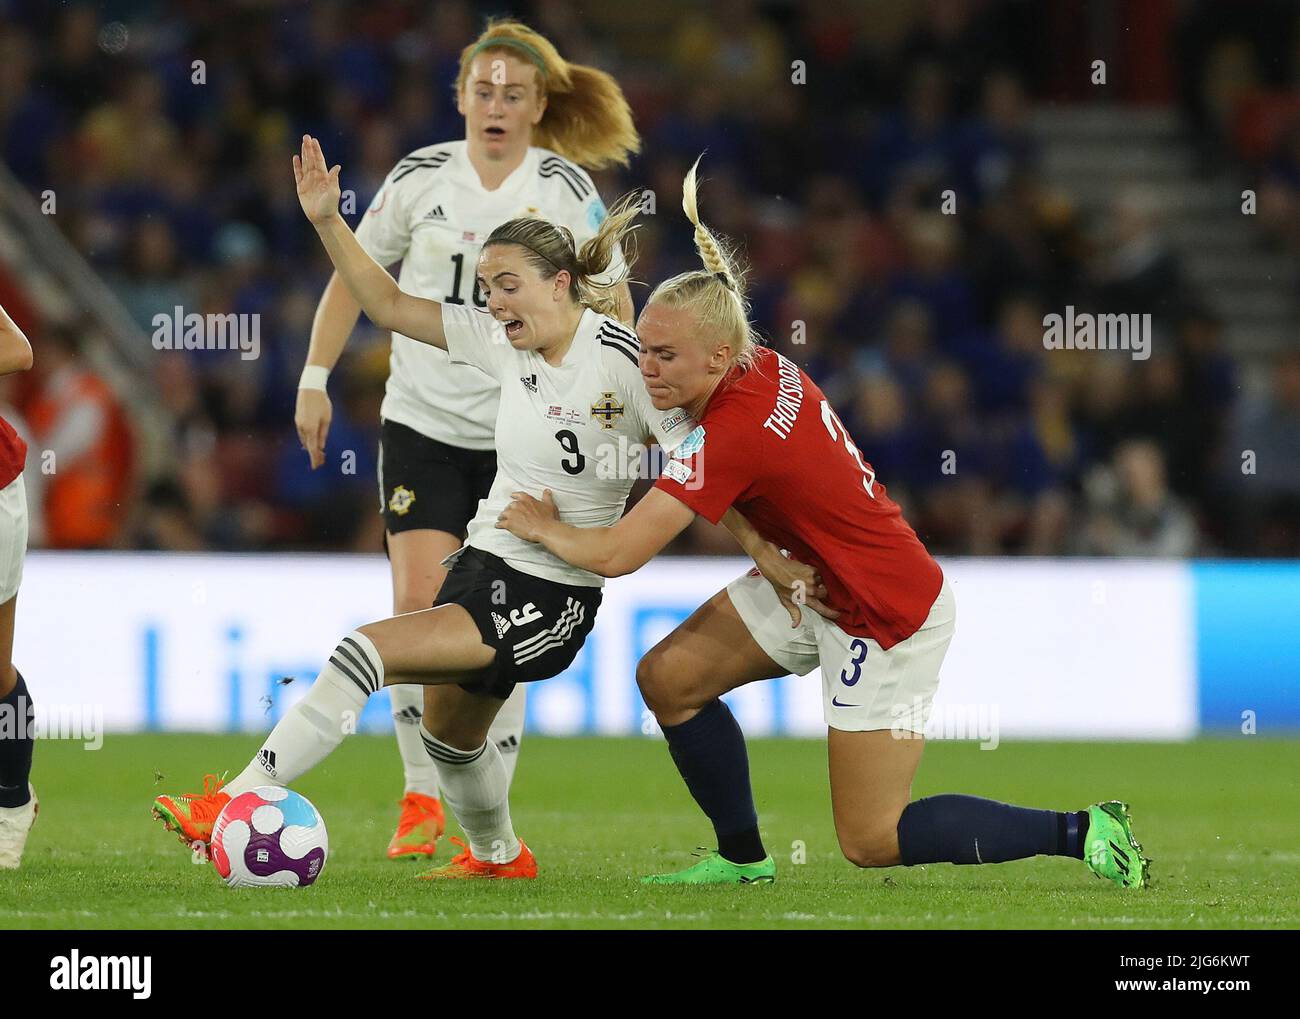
[421,677,537,880]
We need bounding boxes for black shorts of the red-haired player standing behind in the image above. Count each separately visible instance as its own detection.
[380,421,497,538]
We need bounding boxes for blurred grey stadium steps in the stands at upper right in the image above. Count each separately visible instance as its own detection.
[1030,105,1300,357]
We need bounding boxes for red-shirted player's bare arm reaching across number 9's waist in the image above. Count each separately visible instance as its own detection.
[497,489,696,577]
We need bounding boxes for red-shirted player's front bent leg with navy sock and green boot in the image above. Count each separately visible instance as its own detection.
[637,590,785,884]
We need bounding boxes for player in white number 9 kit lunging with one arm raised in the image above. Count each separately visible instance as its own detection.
[153,138,811,879]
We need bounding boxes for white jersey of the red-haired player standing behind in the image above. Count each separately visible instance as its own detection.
[356,140,623,450]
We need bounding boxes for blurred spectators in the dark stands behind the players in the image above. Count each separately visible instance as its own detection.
[0,0,1300,556]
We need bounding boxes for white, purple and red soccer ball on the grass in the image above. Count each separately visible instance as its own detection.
[209,785,329,888]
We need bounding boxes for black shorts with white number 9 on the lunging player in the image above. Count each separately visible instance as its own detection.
[434,547,601,701]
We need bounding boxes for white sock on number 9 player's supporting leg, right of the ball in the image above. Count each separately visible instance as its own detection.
[420,725,519,863]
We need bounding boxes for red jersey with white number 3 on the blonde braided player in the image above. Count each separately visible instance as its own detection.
[655,348,944,649]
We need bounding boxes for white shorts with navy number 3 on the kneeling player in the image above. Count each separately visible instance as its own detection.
[727,572,957,733]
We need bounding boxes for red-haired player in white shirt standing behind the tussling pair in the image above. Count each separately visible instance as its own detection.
[295,21,640,859]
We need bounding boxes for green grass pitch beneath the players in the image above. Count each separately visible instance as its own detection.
[0,734,1300,929]
